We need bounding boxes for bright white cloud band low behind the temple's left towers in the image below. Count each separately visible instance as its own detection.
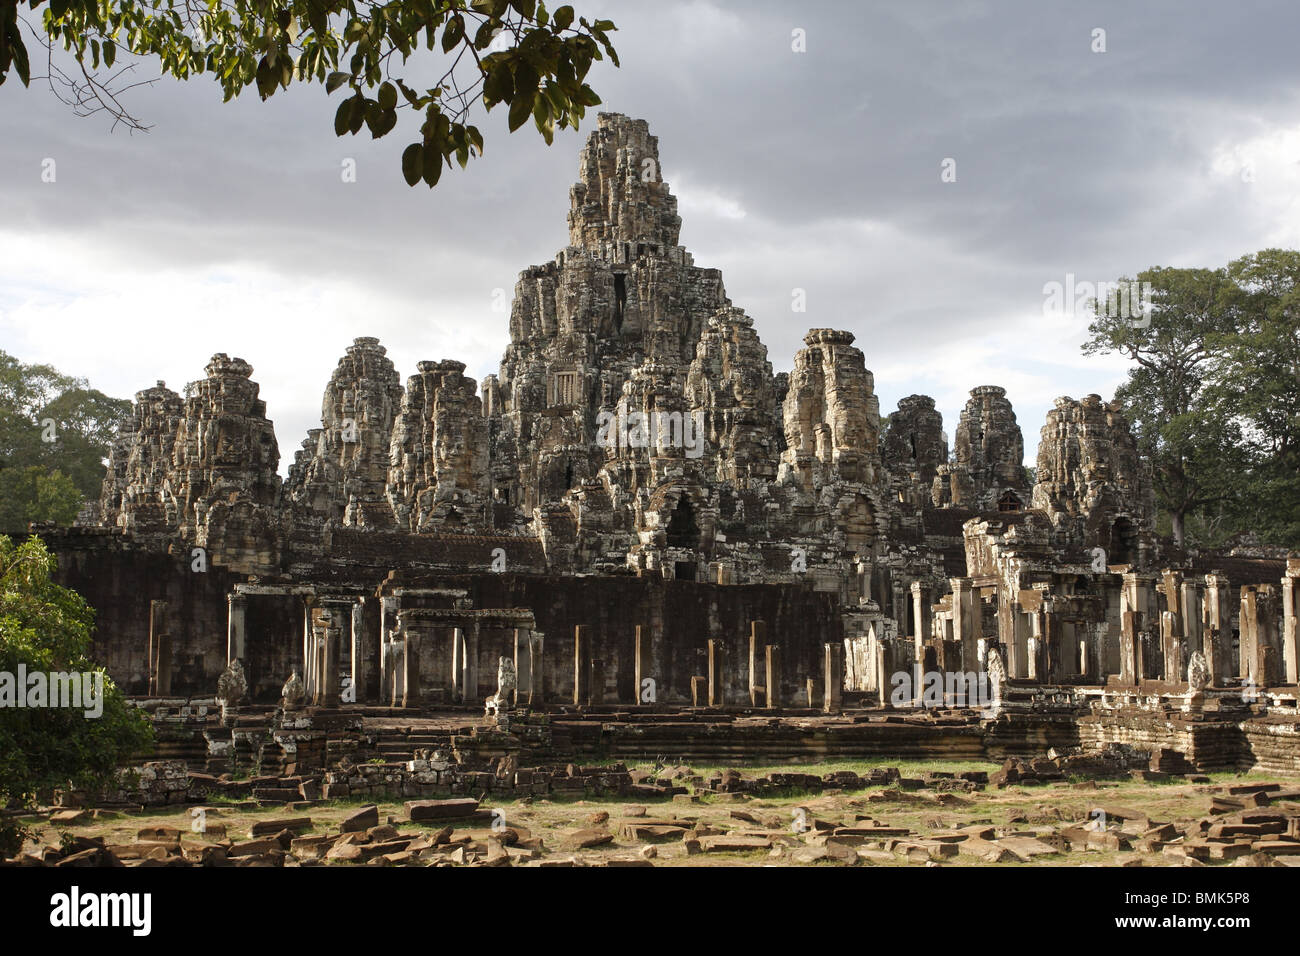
[0,233,507,471]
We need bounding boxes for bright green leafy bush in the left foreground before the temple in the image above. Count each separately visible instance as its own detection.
[0,536,152,856]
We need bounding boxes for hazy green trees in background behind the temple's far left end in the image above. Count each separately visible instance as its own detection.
[0,351,131,531]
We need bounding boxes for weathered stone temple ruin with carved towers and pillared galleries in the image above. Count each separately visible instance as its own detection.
[27,114,1300,790]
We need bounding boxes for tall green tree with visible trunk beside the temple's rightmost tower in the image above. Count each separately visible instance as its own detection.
[1083,267,1244,546]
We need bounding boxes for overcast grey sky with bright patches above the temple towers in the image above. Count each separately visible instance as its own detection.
[0,0,1300,471]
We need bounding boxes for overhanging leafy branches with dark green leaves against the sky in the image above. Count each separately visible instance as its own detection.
[0,0,619,186]
